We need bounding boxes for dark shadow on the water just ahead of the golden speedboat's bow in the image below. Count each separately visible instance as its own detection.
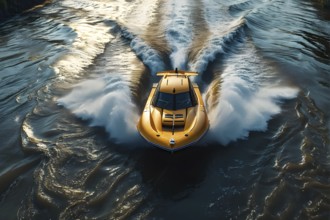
[131,146,222,200]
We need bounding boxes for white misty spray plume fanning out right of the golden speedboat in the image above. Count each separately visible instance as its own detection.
[208,72,298,145]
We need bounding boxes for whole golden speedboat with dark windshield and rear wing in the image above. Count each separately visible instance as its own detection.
[137,69,209,151]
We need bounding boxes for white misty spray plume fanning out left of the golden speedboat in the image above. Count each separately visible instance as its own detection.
[58,76,138,143]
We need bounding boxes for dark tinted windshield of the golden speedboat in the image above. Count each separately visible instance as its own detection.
[153,92,195,110]
